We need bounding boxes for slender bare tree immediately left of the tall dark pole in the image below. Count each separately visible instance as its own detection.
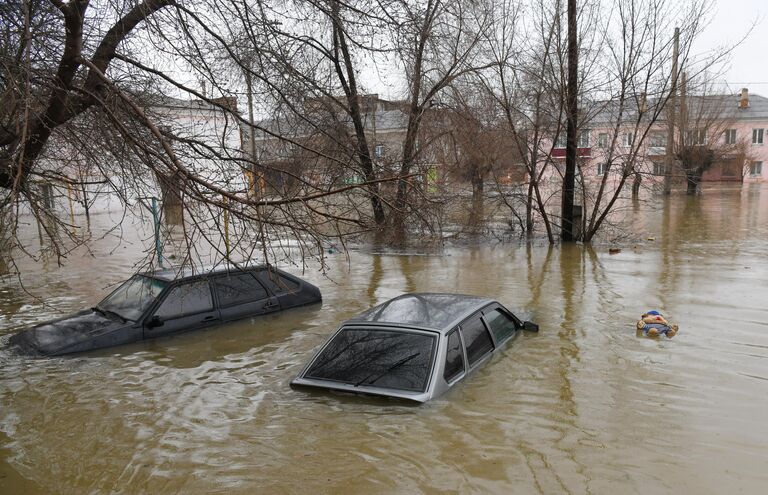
[479,0,576,243]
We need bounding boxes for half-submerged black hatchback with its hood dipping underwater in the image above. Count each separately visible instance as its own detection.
[9,265,322,356]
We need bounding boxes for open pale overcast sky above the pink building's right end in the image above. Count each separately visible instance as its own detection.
[695,0,768,96]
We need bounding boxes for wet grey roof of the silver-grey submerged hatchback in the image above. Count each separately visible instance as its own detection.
[345,293,496,333]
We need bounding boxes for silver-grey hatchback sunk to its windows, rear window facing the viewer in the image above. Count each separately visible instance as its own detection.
[291,294,538,402]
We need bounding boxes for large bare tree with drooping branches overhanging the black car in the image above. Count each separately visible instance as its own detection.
[0,0,412,276]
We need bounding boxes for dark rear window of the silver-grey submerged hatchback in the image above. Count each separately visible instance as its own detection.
[305,328,436,392]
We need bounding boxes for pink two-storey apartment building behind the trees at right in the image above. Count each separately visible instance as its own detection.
[552,88,768,187]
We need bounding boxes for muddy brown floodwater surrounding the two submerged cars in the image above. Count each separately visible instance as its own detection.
[0,185,768,494]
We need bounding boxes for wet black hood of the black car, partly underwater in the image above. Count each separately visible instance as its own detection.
[9,310,130,356]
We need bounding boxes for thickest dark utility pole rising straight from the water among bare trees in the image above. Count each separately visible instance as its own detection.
[560,0,579,242]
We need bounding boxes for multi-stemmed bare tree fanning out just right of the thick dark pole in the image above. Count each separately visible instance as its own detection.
[580,0,723,242]
